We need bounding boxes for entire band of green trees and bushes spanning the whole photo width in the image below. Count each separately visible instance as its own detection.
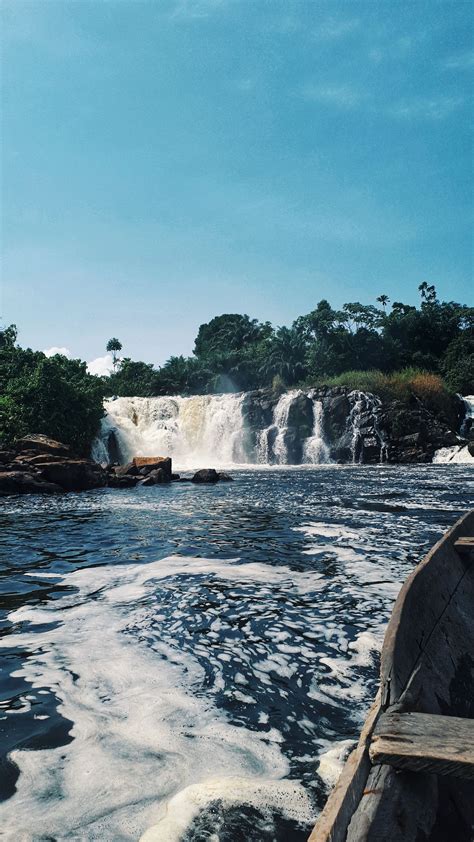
[0,283,474,453]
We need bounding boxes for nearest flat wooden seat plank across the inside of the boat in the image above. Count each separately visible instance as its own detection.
[369,711,474,780]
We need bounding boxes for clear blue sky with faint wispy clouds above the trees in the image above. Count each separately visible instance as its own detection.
[0,0,474,370]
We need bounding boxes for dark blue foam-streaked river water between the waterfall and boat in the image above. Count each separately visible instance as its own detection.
[0,465,474,842]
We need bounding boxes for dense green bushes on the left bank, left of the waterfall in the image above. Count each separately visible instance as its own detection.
[0,334,104,454]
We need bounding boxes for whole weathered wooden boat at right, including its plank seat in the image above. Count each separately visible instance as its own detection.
[309,510,474,842]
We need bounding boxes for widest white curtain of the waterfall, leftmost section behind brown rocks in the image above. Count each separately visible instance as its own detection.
[93,394,248,468]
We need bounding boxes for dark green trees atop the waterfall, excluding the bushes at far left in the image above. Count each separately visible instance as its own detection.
[106,282,474,396]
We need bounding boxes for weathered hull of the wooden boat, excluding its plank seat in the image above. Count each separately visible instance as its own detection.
[310,511,474,842]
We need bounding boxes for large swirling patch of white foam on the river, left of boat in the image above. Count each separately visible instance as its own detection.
[0,558,318,839]
